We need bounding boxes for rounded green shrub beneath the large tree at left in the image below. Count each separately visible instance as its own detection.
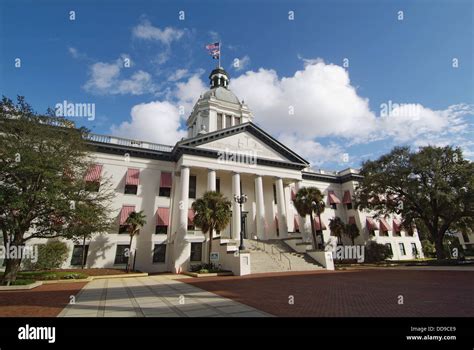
[24,240,69,270]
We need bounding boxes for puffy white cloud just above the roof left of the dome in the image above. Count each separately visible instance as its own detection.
[111,101,186,145]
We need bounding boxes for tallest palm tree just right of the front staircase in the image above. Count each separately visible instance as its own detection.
[294,187,325,249]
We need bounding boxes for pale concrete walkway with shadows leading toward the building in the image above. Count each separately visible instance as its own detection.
[58,275,272,317]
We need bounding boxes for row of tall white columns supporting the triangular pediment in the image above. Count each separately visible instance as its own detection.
[174,166,294,272]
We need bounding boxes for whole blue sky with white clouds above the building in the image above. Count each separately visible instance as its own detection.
[0,0,474,170]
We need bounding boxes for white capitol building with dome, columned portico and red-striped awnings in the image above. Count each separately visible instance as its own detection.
[31,68,422,275]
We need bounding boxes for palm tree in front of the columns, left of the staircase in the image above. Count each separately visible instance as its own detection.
[192,191,232,263]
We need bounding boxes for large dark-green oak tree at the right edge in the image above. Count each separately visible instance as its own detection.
[355,146,474,259]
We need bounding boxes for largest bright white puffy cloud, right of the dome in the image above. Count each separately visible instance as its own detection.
[230,61,376,140]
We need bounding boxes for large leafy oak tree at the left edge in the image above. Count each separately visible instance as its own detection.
[0,97,113,284]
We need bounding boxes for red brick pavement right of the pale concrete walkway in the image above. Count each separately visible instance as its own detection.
[182,269,474,317]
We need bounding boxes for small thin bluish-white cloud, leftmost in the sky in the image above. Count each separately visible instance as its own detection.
[83,55,154,95]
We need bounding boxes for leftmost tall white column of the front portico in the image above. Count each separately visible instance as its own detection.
[173,167,191,273]
